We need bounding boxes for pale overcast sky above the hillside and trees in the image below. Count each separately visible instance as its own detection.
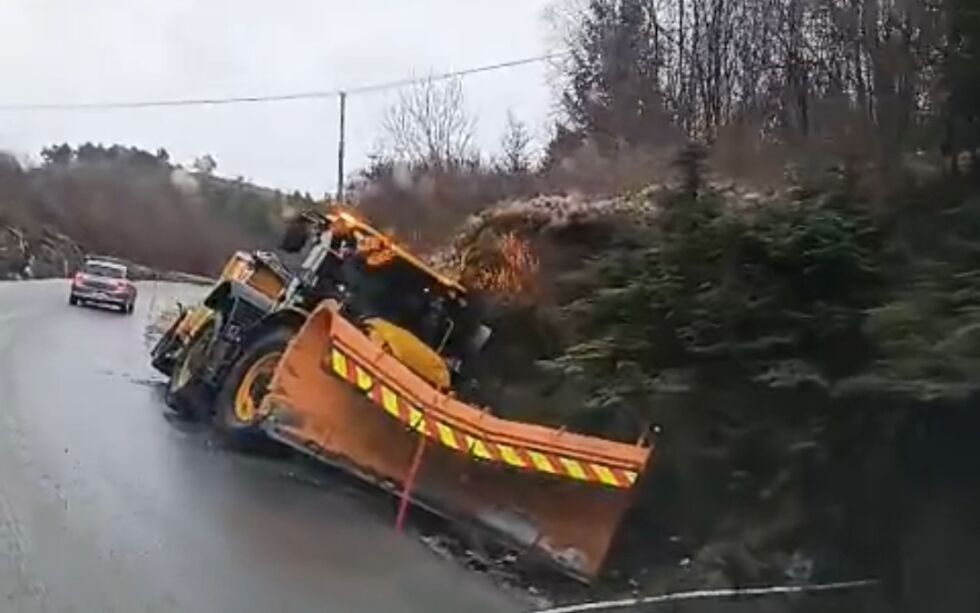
[0,0,551,196]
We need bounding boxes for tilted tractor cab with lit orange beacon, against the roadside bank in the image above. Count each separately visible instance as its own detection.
[281,207,490,389]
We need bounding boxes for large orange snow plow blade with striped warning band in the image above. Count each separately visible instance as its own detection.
[263,305,651,580]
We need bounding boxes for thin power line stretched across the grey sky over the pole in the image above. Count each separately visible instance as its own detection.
[0,53,564,112]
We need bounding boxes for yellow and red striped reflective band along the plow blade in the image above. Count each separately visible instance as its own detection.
[330,347,637,488]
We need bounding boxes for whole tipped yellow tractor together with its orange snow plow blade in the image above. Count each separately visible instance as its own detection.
[151,206,652,581]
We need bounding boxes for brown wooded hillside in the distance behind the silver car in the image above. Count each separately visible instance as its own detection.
[0,144,310,277]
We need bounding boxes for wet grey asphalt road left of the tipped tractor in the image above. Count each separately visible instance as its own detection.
[0,281,521,613]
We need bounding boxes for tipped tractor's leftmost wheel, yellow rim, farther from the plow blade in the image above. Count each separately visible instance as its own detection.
[165,319,220,421]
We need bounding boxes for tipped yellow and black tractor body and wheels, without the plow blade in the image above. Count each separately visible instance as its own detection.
[152,206,488,442]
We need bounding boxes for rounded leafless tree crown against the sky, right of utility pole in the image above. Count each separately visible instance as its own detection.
[382,79,476,169]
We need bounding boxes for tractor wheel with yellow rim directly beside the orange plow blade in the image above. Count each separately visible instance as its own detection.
[214,326,296,451]
